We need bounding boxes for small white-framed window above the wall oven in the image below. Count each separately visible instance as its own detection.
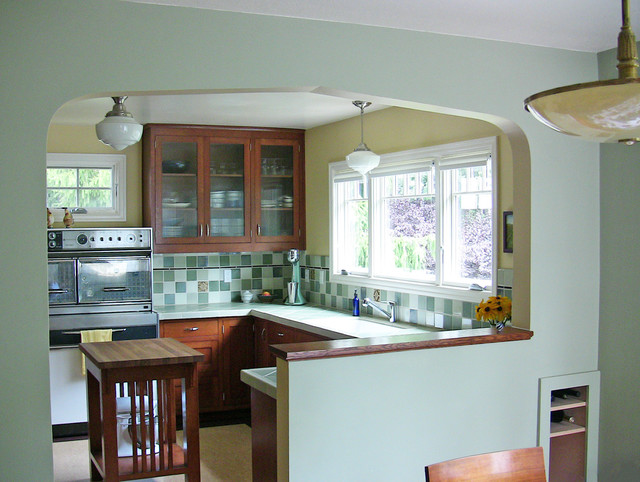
[47,153,127,221]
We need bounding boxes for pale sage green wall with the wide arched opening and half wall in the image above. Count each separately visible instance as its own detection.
[0,0,600,481]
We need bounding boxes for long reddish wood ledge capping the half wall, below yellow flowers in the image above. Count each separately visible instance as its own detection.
[270,326,533,361]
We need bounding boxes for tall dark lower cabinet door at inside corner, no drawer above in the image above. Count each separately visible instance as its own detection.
[222,317,255,408]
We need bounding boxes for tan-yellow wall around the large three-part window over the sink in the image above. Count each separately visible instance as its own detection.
[305,106,513,268]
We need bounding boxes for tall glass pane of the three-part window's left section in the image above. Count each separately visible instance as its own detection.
[334,180,369,273]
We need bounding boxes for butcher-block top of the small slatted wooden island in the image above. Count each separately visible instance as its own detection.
[79,338,204,369]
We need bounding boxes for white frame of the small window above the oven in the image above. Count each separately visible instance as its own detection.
[47,152,127,222]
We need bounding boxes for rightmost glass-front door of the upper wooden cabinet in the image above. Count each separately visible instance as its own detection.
[255,139,300,242]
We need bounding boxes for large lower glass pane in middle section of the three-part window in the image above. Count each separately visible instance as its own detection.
[382,196,436,279]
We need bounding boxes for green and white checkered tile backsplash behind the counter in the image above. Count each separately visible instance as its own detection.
[153,252,513,329]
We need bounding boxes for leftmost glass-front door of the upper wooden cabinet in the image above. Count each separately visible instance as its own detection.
[156,137,202,239]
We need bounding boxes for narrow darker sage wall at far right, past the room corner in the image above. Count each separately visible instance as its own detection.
[599,45,640,481]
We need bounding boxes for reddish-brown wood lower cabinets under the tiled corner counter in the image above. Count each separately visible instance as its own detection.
[160,316,329,412]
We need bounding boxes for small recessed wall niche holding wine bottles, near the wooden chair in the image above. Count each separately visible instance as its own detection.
[538,372,600,482]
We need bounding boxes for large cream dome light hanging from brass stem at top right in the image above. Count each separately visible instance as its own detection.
[524,0,640,145]
